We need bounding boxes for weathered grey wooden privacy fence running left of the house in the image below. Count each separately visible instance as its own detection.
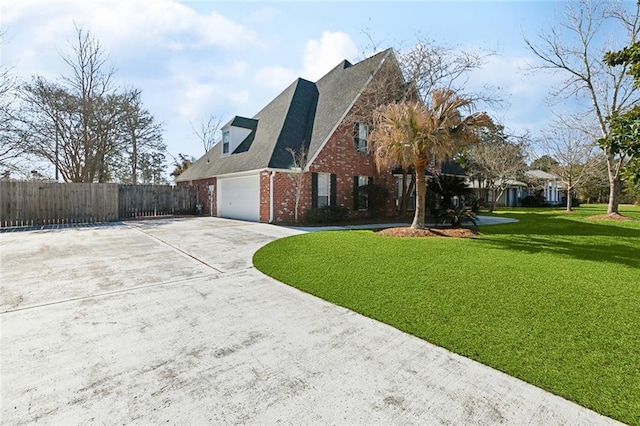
[0,182,197,227]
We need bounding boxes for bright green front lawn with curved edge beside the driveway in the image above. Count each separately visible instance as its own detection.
[254,206,640,425]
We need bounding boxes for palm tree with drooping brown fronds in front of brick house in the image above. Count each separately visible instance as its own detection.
[370,89,493,228]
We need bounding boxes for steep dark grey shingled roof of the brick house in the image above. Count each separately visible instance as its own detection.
[176,49,393,182]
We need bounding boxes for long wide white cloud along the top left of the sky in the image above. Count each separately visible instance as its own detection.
[3,0,260,51]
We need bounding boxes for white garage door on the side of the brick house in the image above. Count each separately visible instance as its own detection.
[217,175,260,222]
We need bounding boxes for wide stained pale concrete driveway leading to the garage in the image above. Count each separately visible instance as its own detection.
[0,218,613,425]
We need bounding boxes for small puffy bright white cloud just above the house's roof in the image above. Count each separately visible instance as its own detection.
[302,31,358,81]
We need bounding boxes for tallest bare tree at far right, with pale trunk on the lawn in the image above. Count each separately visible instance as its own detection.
[525,0,640,214]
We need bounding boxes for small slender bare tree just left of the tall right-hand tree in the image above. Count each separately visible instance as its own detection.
[540,121,597,212]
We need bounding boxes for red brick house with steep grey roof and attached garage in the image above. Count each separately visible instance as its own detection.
[176,49,403,223]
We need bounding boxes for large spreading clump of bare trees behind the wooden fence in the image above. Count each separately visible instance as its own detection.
[18,27,166,183]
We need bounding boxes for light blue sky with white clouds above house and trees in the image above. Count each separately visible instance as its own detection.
[0,0,632,175]
